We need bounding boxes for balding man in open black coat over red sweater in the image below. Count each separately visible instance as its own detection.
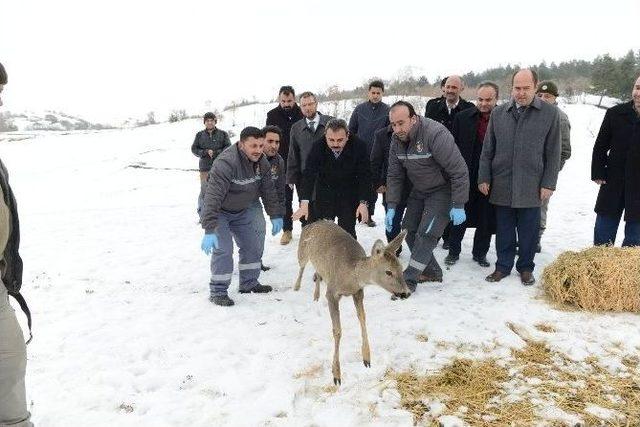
[444,82,498,267]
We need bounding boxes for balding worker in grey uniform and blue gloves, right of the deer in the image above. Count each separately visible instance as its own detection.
[385,101,469,292]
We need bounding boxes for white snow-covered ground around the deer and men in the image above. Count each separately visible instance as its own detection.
[0,104,640,427]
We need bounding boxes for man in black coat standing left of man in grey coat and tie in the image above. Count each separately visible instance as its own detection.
[267,86,303,244]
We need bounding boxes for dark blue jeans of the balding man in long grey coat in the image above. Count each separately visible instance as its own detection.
[496,206,540,274]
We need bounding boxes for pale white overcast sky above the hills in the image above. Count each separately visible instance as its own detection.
[0,0,640,121]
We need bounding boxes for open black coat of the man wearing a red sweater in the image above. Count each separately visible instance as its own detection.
[451,106,496,233]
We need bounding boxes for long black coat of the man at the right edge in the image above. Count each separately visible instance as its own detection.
[591,101,640,221]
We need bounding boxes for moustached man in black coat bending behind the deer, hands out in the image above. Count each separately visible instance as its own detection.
[293,119,371,238]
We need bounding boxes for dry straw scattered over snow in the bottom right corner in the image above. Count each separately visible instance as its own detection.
[388,337,640,427]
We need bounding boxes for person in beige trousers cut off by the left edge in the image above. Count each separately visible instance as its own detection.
[0,60,33,427]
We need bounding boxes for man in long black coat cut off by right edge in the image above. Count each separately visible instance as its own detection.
[591,77,640,246]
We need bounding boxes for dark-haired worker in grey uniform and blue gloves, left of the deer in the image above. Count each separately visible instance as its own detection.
[201,127,284,306]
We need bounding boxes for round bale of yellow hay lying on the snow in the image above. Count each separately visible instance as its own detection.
[542,246,640,312]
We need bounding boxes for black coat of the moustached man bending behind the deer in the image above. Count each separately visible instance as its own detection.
[300,134,371,202]
